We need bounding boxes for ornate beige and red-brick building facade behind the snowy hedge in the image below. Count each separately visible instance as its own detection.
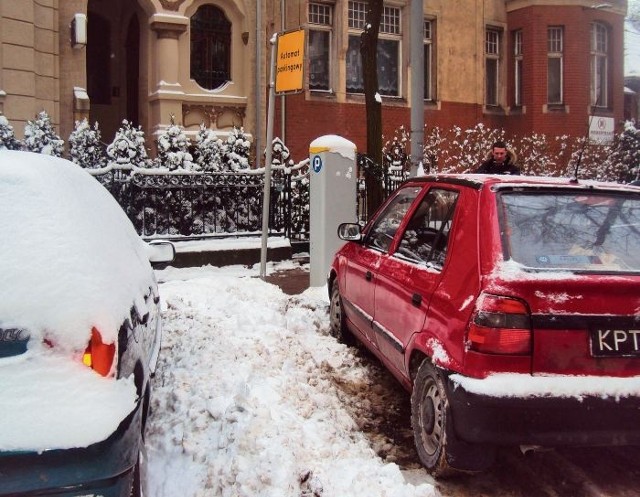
[0,0,627,164]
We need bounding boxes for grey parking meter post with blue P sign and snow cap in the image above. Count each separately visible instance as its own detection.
[309,135,358,287]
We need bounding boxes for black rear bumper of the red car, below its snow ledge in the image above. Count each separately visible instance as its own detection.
[446,377,640,447]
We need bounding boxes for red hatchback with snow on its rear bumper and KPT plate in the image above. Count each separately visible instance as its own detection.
[328,175,640,475]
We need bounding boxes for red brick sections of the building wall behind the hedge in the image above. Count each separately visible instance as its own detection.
[275,5,624,164]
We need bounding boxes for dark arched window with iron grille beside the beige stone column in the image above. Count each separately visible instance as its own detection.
[191,5,231,90]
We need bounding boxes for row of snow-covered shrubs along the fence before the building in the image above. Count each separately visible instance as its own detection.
[5,111,640,182]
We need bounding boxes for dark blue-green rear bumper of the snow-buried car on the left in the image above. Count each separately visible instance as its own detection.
[0,402,142,497]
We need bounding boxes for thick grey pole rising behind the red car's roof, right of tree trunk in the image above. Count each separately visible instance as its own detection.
[409,0,424,176]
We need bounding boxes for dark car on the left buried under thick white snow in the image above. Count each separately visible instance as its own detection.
[0,150,175,497]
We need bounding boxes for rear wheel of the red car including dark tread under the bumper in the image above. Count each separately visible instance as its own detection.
[411,359,497,478]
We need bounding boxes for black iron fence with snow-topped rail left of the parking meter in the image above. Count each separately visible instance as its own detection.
[89,160,309,241]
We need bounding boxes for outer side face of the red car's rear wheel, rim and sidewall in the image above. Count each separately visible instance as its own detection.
[411,359,452,476]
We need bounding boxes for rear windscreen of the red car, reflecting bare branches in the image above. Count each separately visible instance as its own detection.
[499,191,640,272]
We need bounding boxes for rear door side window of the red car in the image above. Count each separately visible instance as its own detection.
[397,188,458,267]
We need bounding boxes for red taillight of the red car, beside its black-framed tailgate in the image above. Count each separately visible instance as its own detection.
[467,294,531,355]
